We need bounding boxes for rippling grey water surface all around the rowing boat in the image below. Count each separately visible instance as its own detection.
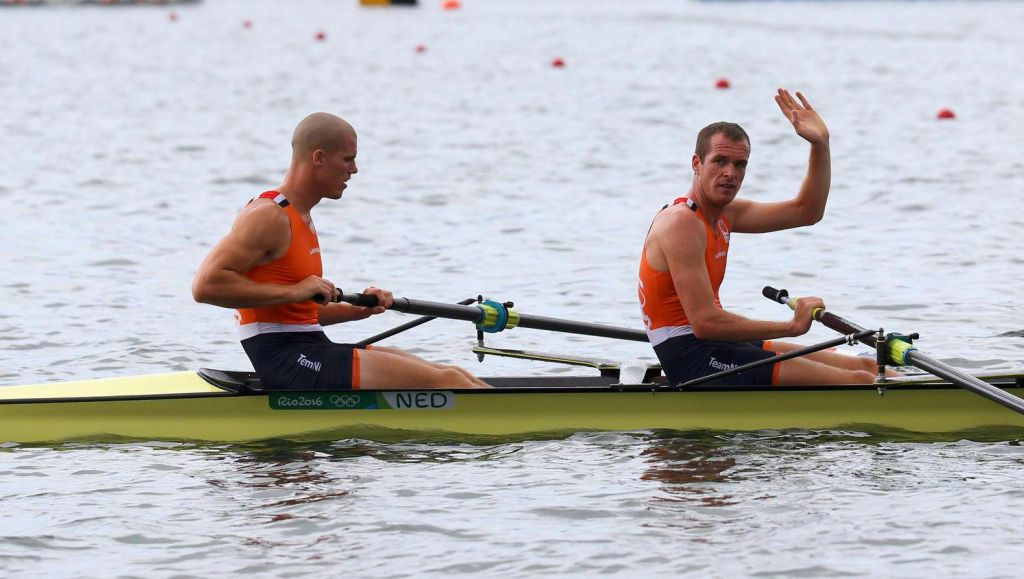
[0,0,1024,577]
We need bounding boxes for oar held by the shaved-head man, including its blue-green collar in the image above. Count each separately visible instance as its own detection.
[313,292,647,342]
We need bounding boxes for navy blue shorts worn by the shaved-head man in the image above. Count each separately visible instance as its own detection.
[242,332,370,390]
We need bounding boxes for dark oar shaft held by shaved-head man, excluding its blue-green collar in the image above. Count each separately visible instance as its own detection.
[338,293,647,342]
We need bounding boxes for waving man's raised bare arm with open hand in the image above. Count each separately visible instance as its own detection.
[726,88,831,234]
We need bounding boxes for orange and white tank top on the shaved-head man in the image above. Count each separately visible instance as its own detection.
[236,191,324,339]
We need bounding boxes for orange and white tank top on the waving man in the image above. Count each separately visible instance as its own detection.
[637,197,729,345]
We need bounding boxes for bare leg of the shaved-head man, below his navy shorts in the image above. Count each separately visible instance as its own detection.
[358,347,490,389]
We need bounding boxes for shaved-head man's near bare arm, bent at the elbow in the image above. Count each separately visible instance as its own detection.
[193,202,335,307]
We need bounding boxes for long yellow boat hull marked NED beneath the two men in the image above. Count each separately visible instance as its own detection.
[6,372,1024,444]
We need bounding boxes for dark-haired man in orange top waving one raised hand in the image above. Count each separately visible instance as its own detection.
[638,89,876,385]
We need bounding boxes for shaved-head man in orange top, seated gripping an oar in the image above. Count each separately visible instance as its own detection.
[193,113,488,389]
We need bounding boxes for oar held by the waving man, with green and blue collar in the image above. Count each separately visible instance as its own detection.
[761,286,1024,414]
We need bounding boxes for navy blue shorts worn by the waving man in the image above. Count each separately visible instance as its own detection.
[654,335,779,386]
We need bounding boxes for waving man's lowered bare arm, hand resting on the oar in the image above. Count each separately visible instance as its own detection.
[647,211,811,341]
